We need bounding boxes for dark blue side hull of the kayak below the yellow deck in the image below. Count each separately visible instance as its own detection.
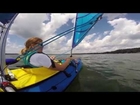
[19,59,83,92]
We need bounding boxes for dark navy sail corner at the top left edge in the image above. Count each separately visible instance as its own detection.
[0,13,16,24]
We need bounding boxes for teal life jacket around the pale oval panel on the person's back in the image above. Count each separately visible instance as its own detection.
[23,52,55,68]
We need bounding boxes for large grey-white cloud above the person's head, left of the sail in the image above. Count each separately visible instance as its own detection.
[10,13,75,39]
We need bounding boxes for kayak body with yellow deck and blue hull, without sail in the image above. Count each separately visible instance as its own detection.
[0,59,82,92]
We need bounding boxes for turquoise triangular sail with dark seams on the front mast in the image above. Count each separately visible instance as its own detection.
[72,13,103,48]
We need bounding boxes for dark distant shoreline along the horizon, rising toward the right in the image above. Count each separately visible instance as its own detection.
[6,48,140,55]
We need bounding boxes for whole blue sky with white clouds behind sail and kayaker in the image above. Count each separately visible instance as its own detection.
[6,13,140,54]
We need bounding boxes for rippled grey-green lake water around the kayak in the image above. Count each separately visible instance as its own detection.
[6,53,140,92]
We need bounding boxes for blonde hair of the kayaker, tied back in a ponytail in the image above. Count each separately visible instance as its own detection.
[21,37,42,54]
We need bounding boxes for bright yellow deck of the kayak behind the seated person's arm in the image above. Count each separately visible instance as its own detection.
[0,61,61,91]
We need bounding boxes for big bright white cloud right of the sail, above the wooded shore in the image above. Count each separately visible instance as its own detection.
[72,18,140,52]
